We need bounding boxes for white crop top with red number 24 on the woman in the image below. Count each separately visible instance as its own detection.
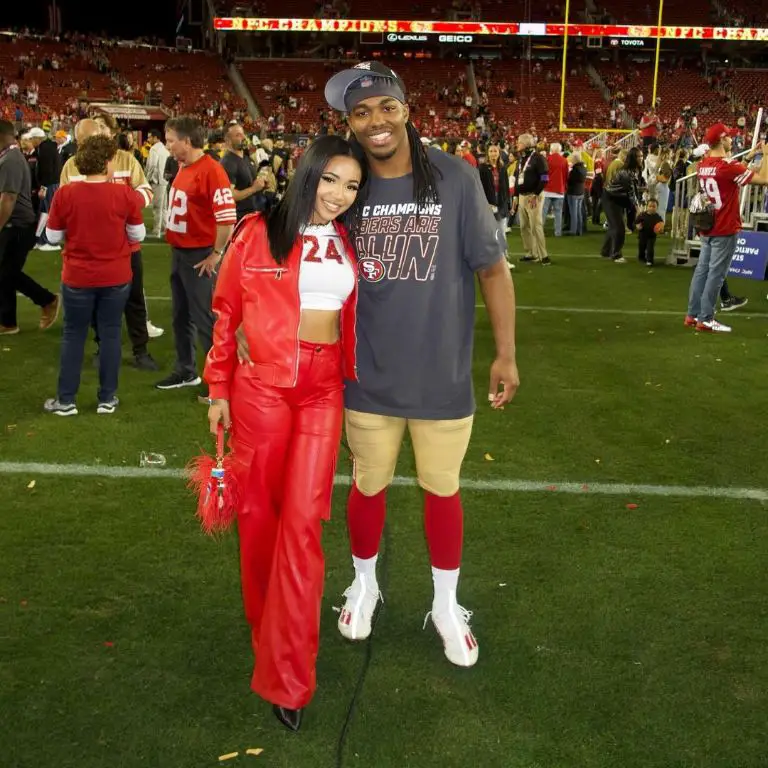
[299,222,355,311]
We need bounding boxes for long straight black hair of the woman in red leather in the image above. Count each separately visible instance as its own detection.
[267,135,368,264]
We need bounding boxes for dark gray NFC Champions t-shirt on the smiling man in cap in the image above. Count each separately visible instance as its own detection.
[345,148,505,419]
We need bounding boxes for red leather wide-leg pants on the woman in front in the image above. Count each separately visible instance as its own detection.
[230,342,343,709]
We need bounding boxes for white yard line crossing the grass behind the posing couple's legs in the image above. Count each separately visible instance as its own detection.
[0,461,768,501]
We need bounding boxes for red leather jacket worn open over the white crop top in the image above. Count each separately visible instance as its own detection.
[203,213,357,400]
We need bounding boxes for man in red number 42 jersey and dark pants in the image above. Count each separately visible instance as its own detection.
[155,117,237,402]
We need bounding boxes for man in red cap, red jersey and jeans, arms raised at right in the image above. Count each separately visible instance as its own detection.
[685,123,768,333]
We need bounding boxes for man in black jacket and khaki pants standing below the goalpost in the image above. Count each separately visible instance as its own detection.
[512,133,552,266]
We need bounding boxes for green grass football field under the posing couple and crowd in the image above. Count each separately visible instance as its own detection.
[0,233,768,768]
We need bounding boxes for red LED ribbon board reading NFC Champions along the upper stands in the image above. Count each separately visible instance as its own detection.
[213,16,768,42]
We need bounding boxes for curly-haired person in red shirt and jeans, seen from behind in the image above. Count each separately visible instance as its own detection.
[43,136,146,416]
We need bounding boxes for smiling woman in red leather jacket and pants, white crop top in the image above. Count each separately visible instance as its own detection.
[204,136,365,731]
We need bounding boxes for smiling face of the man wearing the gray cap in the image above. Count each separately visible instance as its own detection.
[347,96,409,160]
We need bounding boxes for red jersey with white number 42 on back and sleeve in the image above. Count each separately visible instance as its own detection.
[166,155,237,248]
